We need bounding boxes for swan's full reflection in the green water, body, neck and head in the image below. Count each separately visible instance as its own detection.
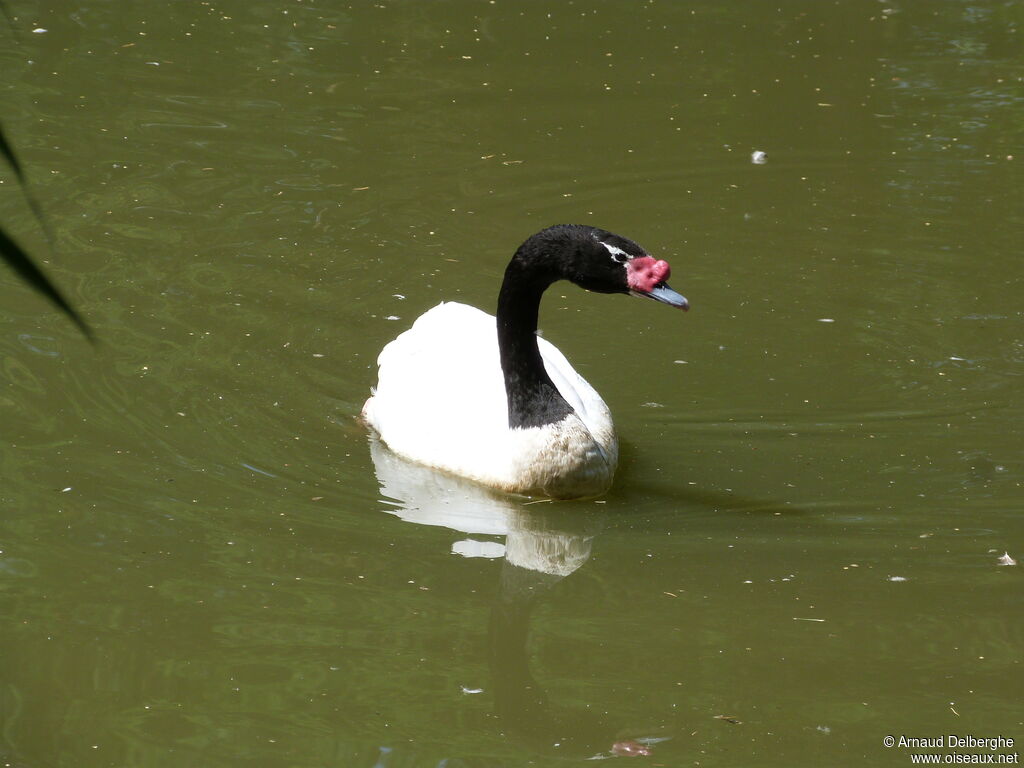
[370,437,660,757]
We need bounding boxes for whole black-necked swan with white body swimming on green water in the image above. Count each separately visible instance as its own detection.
[362,224,687,499]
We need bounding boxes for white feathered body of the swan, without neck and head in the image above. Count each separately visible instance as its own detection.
[362,302,618,498]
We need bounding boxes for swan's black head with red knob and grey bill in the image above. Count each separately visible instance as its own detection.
[513,224,689,309]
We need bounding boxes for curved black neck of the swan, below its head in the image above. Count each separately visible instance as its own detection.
[498,256,572,428]
